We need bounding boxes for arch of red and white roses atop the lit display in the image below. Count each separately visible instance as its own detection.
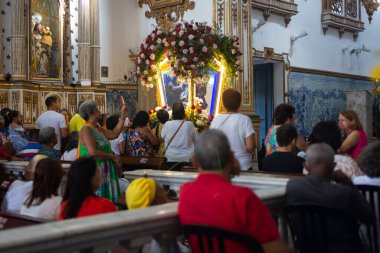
[136,21,241,88]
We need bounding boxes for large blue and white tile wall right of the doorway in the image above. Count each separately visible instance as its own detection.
[289,72,374,137]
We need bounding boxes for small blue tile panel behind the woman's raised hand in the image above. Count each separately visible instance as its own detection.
[106,89,138,120]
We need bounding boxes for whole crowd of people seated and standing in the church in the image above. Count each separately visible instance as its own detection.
[0,89,380,252]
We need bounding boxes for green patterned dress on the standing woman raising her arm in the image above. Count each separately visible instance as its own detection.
[77,123,120,202]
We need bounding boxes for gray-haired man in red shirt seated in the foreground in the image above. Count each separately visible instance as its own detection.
[178,130,290,253]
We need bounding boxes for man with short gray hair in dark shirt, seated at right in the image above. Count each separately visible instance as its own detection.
[286,143,375,252]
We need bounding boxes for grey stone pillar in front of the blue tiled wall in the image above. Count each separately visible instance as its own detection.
[347,90,373,138]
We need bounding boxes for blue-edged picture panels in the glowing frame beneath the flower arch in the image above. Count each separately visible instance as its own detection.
[162,69,221,114]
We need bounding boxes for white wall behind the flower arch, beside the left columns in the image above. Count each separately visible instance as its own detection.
[99,0,212,83]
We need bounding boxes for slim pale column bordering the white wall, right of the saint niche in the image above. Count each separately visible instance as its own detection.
[90,0,100,85]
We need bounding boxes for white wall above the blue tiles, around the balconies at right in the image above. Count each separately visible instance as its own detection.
[252,0,380,76]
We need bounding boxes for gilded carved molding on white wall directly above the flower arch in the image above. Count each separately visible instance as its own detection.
[138,0,195,25]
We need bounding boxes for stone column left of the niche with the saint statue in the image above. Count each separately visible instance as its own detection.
[10,0,26,80]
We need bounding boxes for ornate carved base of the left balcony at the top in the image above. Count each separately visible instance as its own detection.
[252,0,298,27]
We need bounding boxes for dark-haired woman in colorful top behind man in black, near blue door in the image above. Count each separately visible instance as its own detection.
[265,104,307,155]
